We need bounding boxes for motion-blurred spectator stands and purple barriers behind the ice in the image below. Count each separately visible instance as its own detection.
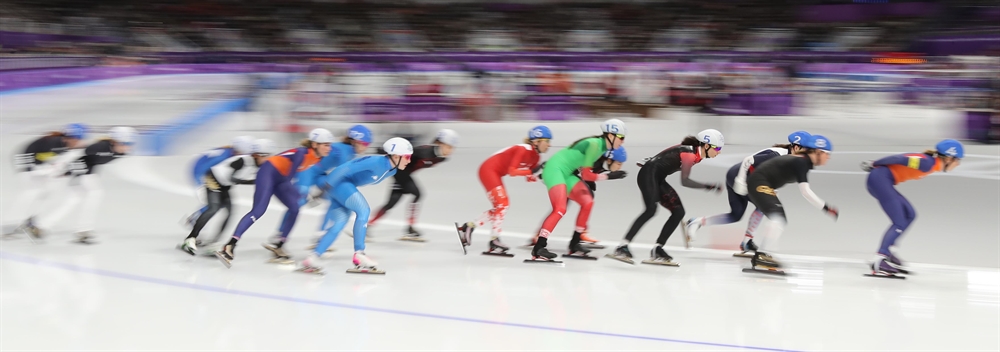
[0,0,1000,147]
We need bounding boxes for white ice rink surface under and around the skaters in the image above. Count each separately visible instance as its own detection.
[0,75,1000,351]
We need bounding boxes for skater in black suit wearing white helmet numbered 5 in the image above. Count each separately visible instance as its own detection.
[607,129,725,265]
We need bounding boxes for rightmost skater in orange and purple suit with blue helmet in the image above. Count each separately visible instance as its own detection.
[861,139,965,276]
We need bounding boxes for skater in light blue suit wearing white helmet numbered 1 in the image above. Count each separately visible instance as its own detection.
[299,137,413,274]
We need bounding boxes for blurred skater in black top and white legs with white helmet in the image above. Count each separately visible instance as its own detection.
[37,126,136,243]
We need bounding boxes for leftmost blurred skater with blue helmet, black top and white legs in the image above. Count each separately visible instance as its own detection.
[4,123,87,238]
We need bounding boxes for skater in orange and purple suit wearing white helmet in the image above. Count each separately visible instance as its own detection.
[215,128,333,268]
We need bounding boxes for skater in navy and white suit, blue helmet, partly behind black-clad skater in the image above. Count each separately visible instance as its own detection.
[682,131,812,257]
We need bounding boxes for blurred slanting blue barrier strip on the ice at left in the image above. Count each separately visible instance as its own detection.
[139,98,251,155]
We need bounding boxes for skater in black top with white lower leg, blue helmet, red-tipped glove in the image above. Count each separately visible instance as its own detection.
[747,135,840,272]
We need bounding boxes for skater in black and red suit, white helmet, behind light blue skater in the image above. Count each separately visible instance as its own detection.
[368,129,458,242]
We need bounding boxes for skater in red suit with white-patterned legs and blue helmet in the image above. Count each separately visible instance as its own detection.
[458,126,552,253]
